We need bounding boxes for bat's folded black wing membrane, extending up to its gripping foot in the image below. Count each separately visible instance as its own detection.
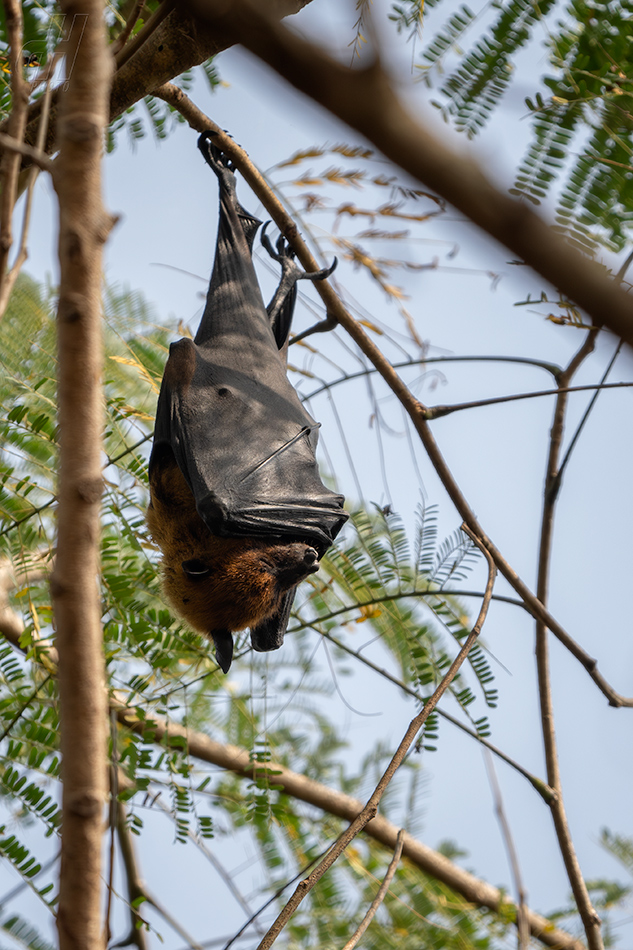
[150,133,348,552]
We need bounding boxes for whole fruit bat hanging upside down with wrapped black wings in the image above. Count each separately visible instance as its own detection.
[147,133,348,673]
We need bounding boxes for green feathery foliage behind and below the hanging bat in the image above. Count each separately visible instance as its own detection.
[0,278,509,950]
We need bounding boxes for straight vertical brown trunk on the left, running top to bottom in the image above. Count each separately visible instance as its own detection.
[51,0,113,950]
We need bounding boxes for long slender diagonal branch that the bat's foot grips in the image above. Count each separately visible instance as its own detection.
[153,83,633,707]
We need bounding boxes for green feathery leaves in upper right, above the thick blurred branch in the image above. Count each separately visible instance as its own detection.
[392,0,633,252]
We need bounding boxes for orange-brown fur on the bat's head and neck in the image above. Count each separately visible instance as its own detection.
[147,456,316,634]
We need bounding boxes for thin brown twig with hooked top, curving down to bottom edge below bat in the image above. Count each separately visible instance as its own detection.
[257,525,497,950]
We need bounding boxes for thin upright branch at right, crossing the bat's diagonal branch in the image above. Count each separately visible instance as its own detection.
[536,330,603,950]
